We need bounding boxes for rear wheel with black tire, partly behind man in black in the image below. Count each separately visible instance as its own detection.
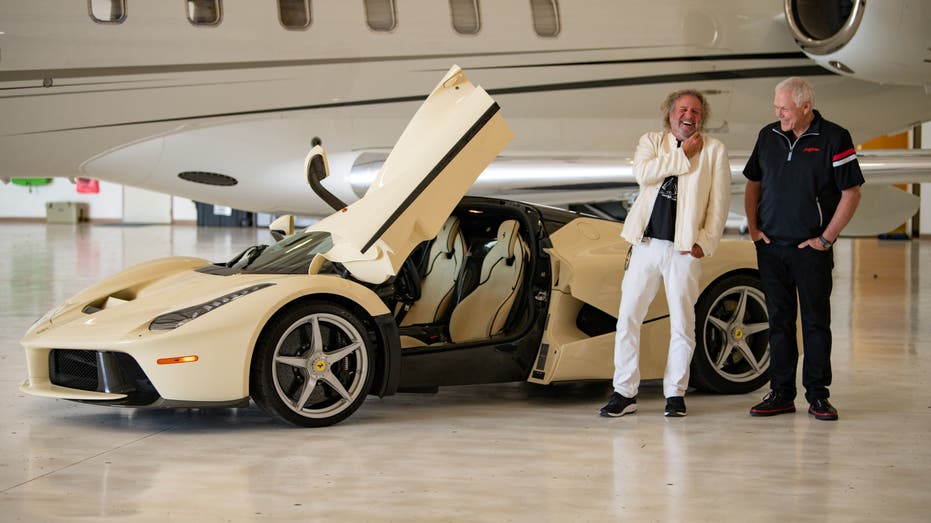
[691,274,770,394]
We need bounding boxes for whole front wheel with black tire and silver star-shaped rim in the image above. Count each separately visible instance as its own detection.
[249,301,374,427]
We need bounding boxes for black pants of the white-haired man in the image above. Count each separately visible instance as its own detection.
[756,240,834,403]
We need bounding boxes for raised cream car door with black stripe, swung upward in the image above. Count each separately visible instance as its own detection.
[307,66,513,284]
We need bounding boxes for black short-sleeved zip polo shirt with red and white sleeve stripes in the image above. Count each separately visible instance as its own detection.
[744,111,864,244]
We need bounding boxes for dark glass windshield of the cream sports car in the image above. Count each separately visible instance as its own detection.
[238,231,333,274]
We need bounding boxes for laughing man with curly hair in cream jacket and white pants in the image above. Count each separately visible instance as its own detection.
[601,89,731,417]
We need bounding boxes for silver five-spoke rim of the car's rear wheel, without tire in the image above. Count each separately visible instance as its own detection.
[699,285,770,383]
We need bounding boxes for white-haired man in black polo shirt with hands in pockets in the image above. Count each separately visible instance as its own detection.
[744,77,863,420]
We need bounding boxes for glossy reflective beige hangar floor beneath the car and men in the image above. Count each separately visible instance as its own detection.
[0,223,931,522]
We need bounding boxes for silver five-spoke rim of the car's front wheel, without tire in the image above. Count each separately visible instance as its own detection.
[272,312,369,418]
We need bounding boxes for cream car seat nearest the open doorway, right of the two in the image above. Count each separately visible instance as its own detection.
[449,220,528,343]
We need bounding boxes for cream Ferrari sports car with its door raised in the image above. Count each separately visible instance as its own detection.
[20,67,769,427]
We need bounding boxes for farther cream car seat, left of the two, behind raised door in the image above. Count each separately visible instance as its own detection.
[400,216,466,326]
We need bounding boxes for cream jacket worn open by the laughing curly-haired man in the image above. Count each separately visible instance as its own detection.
[621,131,731,256]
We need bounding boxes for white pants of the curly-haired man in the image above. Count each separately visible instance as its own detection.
[614,239,701,398]
